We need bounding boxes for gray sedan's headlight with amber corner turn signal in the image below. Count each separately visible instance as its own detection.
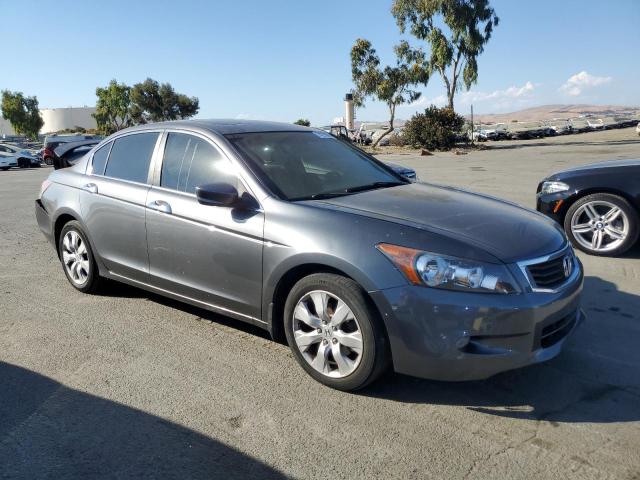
[377,243,519,293]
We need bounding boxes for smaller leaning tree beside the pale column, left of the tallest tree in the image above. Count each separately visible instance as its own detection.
[351,38,429,148]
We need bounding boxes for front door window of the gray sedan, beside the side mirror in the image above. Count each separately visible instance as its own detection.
[160,133,237,193]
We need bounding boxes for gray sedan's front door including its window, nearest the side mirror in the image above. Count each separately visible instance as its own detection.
[147,131,264,318]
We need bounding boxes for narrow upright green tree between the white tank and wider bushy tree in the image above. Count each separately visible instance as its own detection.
[93,79,132,135]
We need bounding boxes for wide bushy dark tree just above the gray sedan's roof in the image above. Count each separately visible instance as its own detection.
[131,78,200,123]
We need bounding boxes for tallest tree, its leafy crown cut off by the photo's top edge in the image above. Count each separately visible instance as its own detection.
[391,0,499,109]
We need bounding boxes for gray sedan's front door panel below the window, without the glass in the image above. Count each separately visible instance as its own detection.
[146,187,264,318]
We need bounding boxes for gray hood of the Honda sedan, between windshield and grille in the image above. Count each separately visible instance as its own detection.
[313,183,566,263]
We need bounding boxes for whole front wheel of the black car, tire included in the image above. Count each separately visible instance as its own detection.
[564,193,639,256]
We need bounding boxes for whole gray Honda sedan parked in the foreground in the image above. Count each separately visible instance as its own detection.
[35,120,583,390]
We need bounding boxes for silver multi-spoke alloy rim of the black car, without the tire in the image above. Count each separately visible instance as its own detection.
[571,200,629,252]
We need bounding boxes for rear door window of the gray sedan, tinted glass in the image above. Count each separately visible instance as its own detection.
[104,132,158,183]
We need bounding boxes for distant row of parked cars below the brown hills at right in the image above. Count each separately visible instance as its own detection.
[473,117,640,142]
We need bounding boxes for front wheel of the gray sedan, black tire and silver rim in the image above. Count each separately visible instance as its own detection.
[284,273,390,391]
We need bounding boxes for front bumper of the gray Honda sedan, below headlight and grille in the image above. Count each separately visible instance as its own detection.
[371,266,584,381]
